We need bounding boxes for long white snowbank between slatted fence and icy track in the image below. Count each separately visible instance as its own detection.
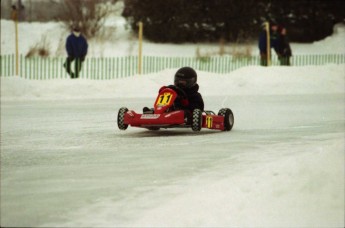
[1,65,345,100]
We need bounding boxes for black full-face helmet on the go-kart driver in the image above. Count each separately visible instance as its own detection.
[174,67,198,89]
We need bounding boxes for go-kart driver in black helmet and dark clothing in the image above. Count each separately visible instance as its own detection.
[143,67,204,113]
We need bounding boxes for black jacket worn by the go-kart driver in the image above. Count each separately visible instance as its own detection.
[174,84,204,112]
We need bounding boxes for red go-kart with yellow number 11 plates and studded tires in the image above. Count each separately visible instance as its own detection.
[117,86,234,131]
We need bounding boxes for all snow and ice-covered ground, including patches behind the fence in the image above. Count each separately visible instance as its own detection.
[1,17,345,227]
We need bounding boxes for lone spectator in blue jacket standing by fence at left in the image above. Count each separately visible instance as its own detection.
[64,27,88,78]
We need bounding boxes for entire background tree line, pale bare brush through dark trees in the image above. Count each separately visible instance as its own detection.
[1,0,345,43]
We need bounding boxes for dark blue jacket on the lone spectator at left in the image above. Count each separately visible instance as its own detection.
[66,33,88,59]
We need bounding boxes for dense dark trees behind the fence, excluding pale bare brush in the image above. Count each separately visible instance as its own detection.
[122,0,345,43]
